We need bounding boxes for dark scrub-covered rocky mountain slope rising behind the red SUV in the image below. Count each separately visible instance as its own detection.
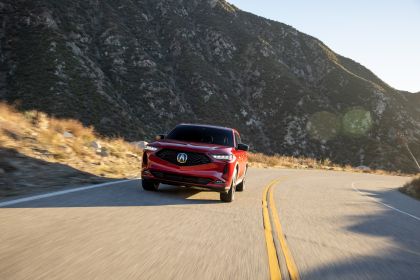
[0,0,420,171]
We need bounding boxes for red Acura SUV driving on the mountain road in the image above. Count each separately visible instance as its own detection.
[141,124,249,202]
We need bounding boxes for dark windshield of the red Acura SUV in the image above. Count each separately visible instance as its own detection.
[167,125,234,147]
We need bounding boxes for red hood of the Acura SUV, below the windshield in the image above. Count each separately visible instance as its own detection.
[150,139,232,154]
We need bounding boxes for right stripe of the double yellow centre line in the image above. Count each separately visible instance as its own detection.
[269,181,299,280]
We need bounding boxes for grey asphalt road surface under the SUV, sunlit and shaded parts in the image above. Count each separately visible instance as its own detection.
[0,169,420,280]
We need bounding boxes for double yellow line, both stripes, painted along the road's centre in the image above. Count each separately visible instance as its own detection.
[262,179,299,280]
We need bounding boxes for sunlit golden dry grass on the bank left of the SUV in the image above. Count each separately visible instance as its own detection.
[0,103,142,178]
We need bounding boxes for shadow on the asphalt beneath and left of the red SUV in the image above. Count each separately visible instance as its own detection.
[1,179,220,208]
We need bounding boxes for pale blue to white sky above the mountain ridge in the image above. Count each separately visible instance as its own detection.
[227,0,420,92]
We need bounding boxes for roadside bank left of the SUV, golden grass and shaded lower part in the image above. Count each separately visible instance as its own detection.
[0,103,142,198]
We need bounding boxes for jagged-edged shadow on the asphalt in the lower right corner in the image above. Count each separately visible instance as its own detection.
[302,190,420,280]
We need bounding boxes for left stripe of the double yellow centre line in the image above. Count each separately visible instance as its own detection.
[262,180,281,280]
